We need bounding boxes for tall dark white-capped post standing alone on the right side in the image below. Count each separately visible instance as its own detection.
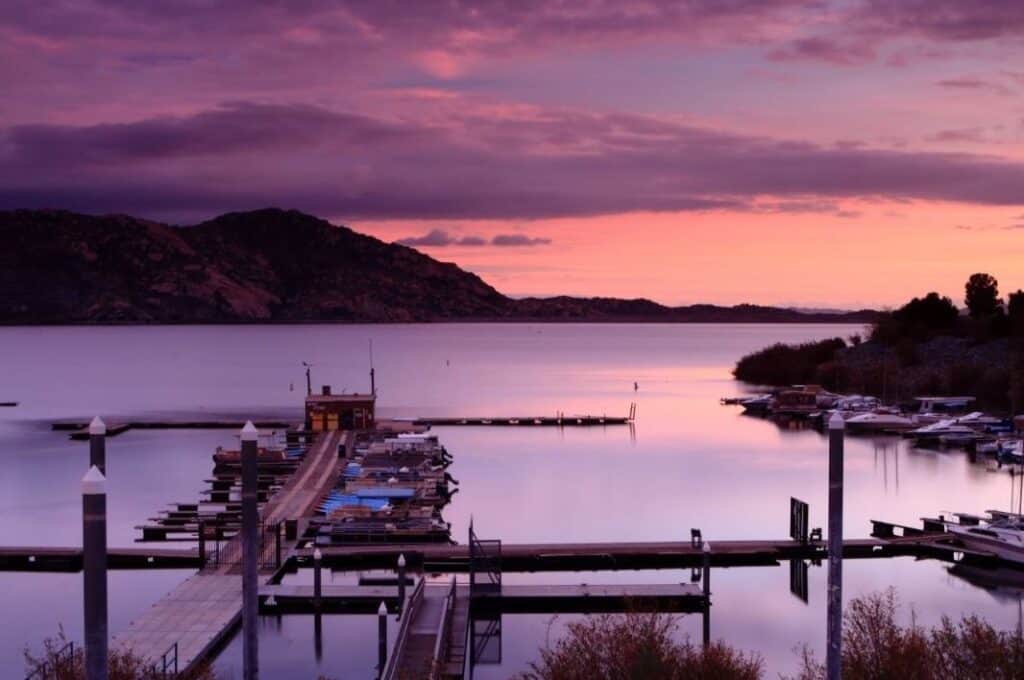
[825,413,845,680]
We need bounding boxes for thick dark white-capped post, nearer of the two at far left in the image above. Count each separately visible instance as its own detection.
[82,466,108,680]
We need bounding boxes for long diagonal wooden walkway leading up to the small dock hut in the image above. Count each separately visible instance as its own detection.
[112,431,344,673]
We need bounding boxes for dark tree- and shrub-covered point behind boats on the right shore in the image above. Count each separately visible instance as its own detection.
[733,273,1024,413]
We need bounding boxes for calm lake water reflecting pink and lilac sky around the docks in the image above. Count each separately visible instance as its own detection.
[0,325,1018,678]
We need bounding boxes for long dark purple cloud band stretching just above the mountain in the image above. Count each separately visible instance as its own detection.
[0,103,1024,220]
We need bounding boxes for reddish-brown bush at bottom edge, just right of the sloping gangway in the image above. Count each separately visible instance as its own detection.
[518,613,763,680]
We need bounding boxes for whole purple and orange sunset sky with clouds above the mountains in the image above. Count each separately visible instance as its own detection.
[0,0,1024,308]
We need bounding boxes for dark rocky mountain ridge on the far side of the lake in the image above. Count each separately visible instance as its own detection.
[0,209,876,324]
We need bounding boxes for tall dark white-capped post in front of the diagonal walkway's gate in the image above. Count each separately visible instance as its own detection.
[242,421,259,680]
